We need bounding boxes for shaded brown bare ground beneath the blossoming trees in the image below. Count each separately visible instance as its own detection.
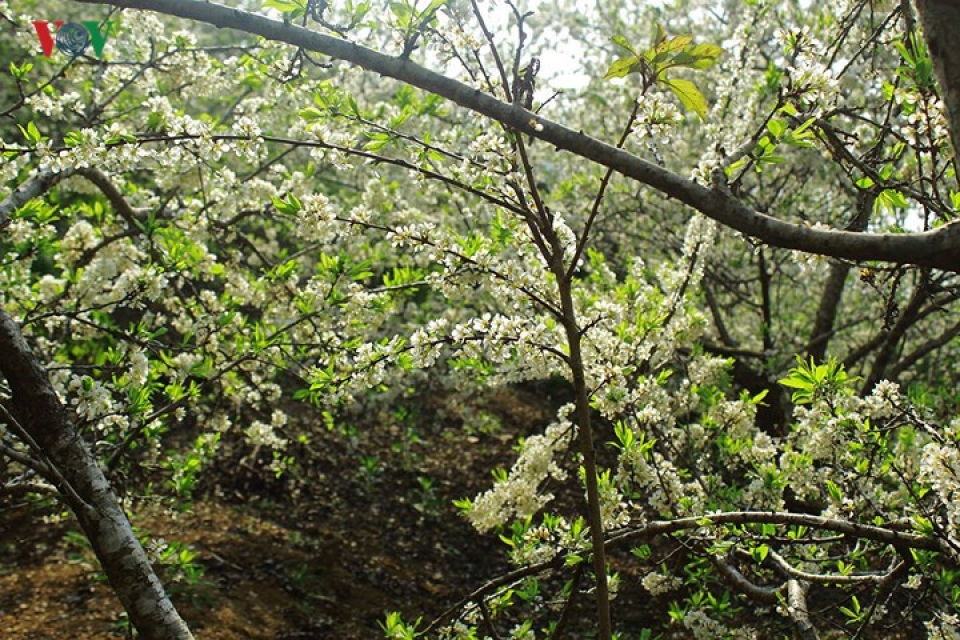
[0,391,551,640]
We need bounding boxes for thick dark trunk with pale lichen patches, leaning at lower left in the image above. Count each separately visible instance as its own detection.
[0,307,193,640]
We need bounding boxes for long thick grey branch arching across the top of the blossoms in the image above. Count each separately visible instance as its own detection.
[71,0,960,272]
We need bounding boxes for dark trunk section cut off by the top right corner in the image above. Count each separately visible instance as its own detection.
[916,0,960,162]
